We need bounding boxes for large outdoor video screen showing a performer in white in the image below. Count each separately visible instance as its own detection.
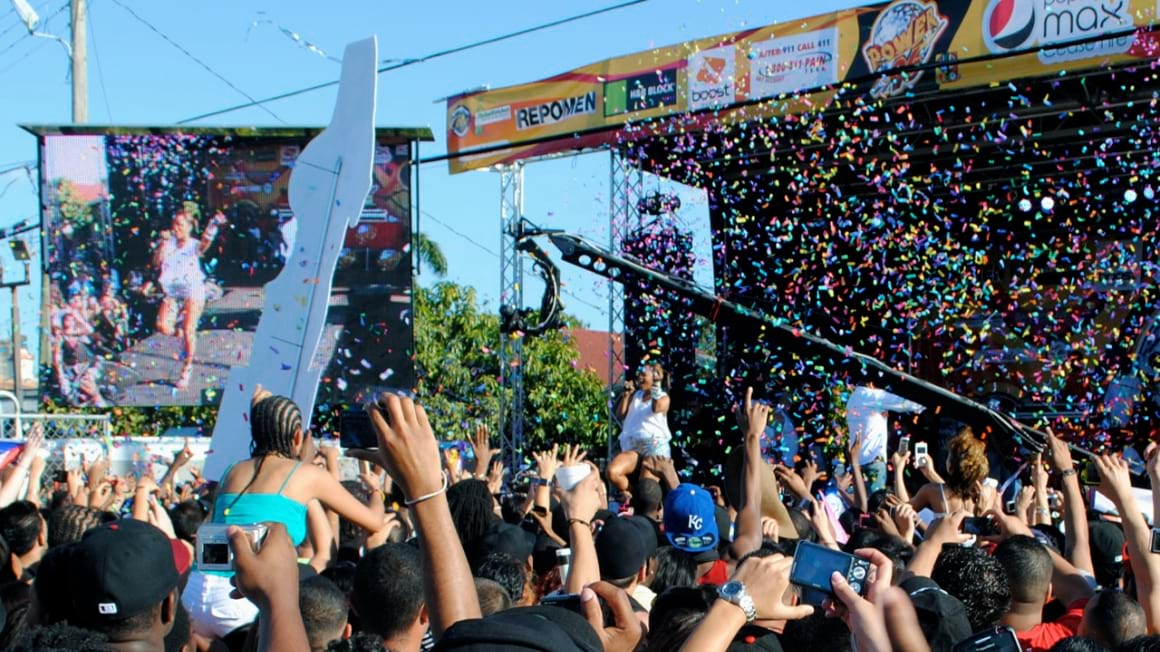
[28,126,430,407]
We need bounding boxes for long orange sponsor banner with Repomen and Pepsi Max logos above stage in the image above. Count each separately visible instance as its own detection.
[447,0,1160,173]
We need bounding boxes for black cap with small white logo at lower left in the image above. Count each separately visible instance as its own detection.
[56,519,180,623]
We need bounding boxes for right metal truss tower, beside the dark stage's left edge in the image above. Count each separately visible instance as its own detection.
[608,147,644,459]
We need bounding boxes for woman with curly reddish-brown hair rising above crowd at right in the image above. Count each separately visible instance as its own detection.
[896,427,991,517]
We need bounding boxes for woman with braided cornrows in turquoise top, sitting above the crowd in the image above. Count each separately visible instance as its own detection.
[182,385,389,637]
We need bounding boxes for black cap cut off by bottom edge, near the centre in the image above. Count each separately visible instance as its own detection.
[435,606,604,652]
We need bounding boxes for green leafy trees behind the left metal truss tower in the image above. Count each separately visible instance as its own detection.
[414,282,608,452]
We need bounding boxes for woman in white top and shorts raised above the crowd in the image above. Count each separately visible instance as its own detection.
[608,364,673,495]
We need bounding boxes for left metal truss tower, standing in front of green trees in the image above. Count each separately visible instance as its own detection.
[499,162,524,457]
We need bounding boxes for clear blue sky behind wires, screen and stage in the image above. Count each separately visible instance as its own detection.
[0,0,865,366]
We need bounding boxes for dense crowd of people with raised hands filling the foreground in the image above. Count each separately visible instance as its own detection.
[0,380,1160,652]
